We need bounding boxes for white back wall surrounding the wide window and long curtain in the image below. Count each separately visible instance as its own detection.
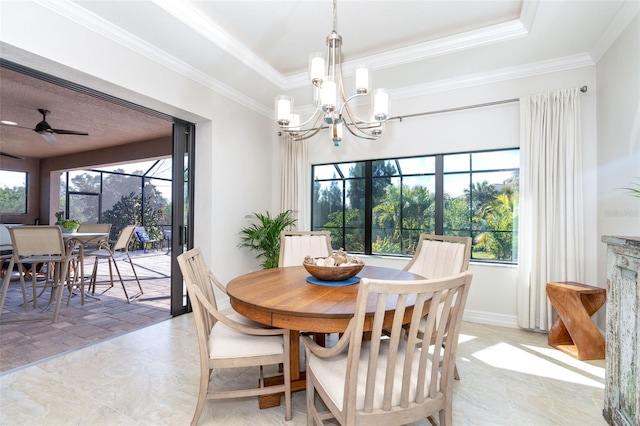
[304,66,599,327]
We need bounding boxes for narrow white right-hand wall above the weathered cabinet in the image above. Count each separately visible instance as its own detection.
[594,15,640,328]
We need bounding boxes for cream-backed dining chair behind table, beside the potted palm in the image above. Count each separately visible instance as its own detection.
[278,231,333,267]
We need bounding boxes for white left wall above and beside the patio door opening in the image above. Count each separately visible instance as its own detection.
[0,2,277,288]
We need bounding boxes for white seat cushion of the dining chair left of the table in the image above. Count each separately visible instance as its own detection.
[209,321,284,359]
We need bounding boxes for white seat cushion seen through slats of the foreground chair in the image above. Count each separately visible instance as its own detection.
[308,339,438,411]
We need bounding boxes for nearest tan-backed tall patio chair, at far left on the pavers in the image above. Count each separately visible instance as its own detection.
[0,225,84,322]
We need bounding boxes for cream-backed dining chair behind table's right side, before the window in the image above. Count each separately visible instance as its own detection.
[404,234,471,380]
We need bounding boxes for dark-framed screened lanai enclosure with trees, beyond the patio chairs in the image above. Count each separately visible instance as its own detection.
[60,158,172,244]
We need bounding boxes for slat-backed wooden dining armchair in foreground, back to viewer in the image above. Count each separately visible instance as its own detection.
[302,272,472,426]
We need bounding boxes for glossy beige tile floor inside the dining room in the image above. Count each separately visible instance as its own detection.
[0,314,606,426]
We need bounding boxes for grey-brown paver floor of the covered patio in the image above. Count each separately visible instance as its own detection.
[0,250,171,371]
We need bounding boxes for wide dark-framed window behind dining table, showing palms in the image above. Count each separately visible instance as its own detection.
[311,149,520,263]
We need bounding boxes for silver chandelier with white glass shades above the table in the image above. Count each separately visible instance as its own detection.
[275,0,389,146]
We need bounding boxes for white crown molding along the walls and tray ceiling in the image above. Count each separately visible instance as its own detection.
[30,0,596,117]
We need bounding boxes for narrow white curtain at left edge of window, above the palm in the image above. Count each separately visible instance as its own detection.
[280,132,307,227]
